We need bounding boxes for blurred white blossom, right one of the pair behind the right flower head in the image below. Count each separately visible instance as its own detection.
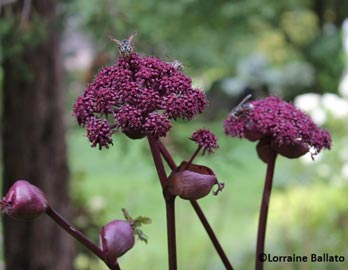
[321,94,348,119]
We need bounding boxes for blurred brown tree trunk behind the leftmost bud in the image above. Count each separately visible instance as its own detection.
[2,0,74,270]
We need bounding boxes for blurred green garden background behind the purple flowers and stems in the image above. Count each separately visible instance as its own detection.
[0,0,348,270]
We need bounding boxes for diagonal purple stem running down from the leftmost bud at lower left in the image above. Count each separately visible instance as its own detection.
[46,206,121,270]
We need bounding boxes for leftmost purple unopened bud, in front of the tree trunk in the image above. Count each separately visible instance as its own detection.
[0,180,48,220]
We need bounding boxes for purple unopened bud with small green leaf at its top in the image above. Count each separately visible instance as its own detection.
[99,220,135,264]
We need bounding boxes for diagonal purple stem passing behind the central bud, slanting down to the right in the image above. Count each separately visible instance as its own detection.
[159,142,233,270]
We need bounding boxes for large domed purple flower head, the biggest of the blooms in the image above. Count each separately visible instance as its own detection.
[73,53,207,148]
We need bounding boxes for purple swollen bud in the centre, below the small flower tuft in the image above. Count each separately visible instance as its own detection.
[166,164,224,200]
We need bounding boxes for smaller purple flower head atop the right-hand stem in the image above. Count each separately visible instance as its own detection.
[224,97,331,158]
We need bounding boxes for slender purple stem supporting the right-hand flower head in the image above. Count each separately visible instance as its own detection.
[255,153,277,270]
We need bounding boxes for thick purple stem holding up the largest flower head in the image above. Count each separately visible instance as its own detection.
[148,137,177,270]
